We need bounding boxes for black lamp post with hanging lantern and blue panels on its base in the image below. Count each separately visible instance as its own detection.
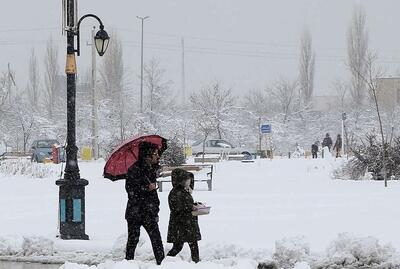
[56,0,110,240]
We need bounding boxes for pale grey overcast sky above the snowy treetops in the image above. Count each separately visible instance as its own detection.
[0,0,400,95]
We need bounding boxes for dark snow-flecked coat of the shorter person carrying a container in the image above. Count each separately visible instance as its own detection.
[167,186,201,243]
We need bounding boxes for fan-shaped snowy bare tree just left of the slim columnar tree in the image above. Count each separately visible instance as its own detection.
[269,78,298,123]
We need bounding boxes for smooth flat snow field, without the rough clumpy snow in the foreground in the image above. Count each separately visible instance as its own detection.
[0,159,400,266]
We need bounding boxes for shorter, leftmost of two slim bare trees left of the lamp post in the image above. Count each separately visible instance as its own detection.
[27,48,40,108]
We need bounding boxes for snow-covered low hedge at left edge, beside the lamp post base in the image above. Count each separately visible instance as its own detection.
[0,159,60,178]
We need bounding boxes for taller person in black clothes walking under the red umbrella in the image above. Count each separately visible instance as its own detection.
[125,142,164,265]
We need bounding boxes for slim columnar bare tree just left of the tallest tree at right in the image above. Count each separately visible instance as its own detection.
[299,28,315,105]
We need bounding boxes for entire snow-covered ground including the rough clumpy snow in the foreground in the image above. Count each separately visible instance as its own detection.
[0,158,400,269]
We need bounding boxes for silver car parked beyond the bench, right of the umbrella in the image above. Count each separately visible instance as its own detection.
[192,139,253,157]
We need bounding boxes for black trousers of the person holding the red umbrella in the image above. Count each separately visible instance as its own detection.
[126,218,164,264]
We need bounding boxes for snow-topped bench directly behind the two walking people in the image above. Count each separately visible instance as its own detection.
[157,164,214,192]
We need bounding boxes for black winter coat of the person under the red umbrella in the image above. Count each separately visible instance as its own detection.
[125,161,160,220]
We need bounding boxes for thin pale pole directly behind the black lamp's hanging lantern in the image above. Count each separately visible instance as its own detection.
[90,27,99,160]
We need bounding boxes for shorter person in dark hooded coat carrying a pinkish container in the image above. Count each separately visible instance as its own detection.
[167,168,201,263]
